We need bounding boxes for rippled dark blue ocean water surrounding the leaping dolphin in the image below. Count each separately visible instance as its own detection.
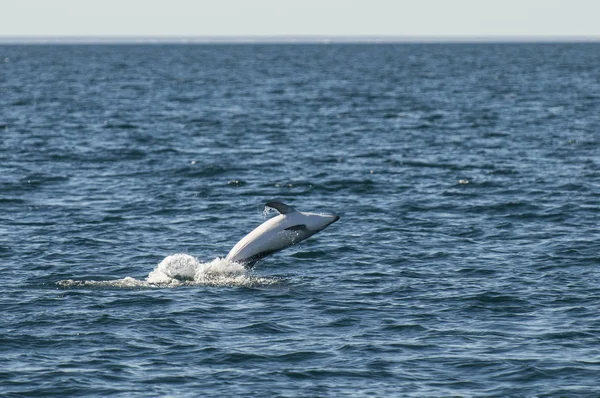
[0,43,600,397]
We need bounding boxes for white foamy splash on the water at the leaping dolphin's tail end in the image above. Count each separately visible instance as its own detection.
[56,253,280,288]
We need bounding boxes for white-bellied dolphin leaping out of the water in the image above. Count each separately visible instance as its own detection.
[226,202,340,268]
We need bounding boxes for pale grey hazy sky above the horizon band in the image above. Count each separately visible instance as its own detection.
[0,0,600,37]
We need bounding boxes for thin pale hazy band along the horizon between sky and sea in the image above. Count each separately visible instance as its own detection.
[0,35,600,44]
